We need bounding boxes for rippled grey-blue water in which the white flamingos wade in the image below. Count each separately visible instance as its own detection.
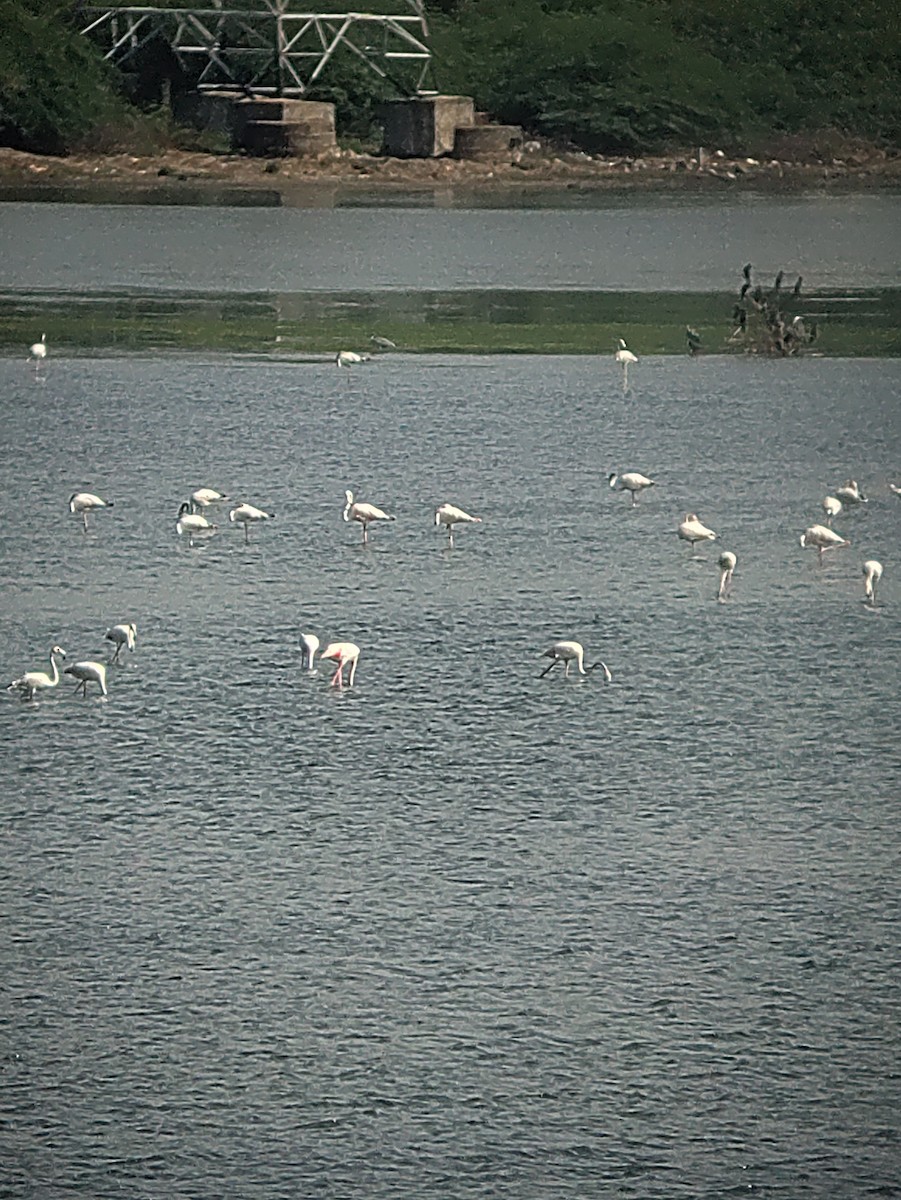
[0,356,901,1200]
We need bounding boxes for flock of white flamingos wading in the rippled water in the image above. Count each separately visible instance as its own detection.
[7,335,901,701]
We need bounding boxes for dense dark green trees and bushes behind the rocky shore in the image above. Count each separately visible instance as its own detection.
[0,0,901,154]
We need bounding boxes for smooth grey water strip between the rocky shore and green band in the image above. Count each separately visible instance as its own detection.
[0,192,901,293]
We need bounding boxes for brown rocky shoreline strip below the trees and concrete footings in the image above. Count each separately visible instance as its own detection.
[0,148,901,204]
